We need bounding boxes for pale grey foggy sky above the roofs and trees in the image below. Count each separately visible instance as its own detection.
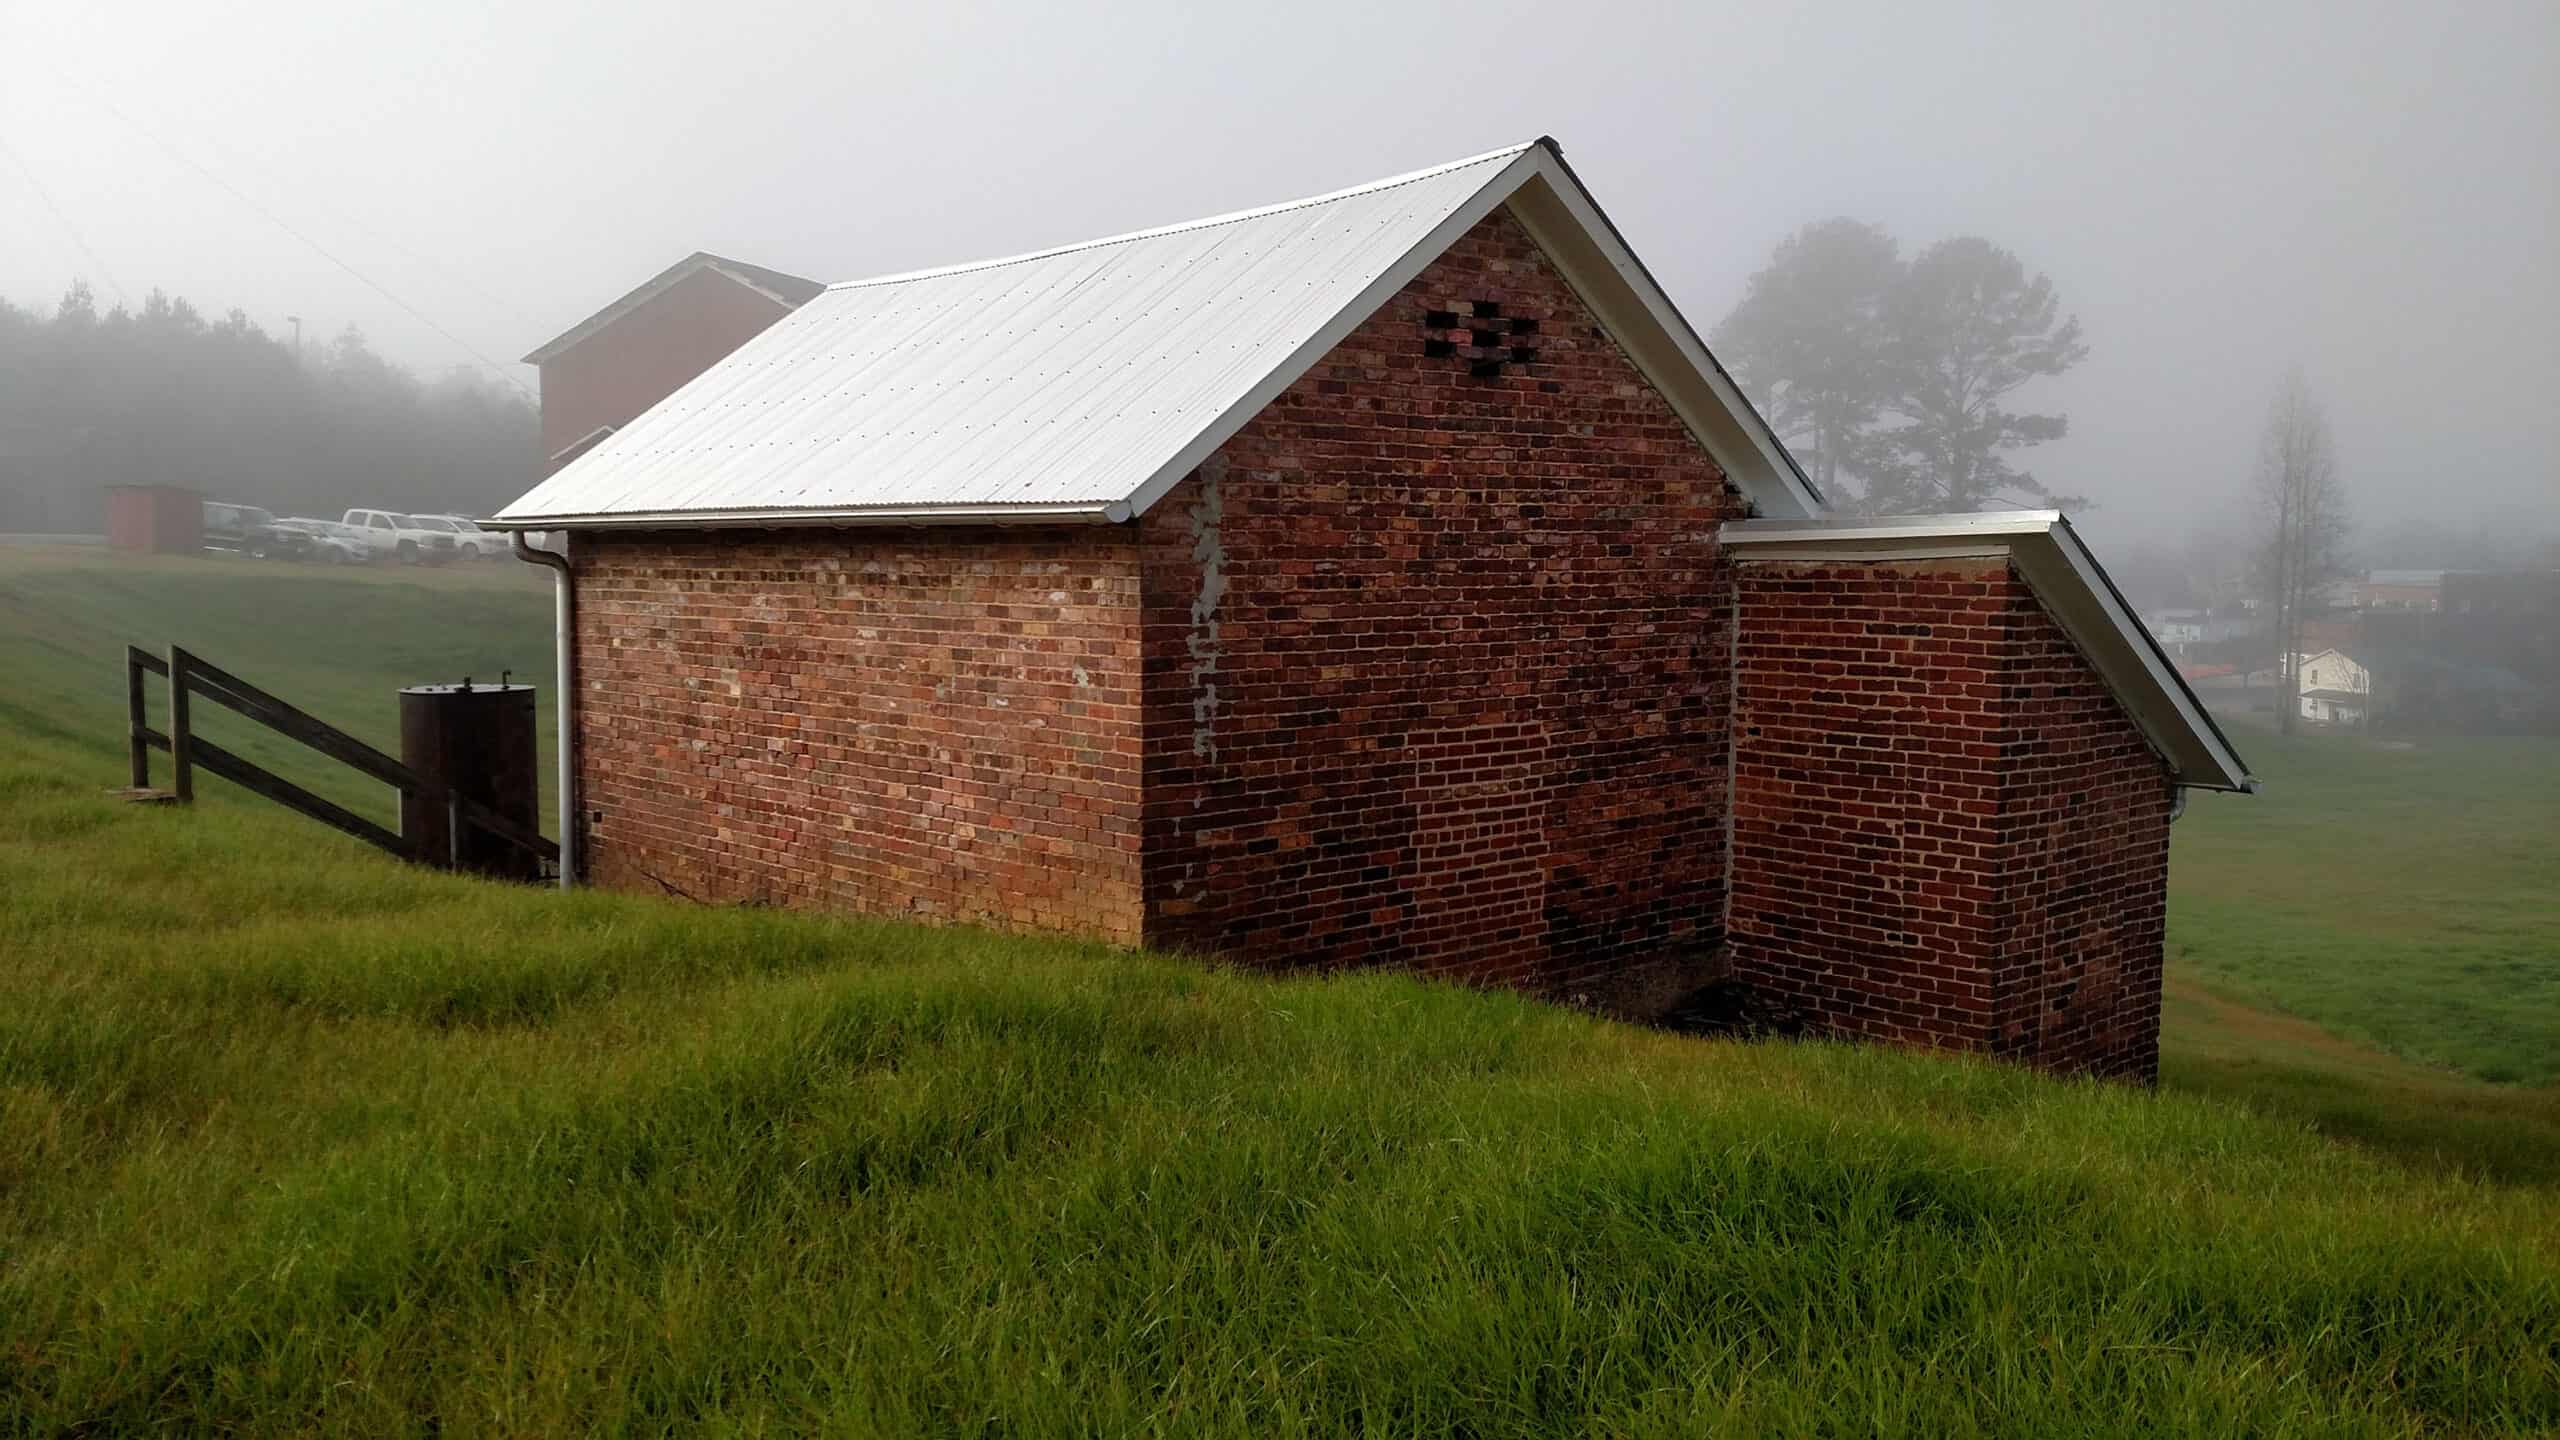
[0,0,2560,538]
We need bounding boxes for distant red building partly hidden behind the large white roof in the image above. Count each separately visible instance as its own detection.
[525,251,827,474]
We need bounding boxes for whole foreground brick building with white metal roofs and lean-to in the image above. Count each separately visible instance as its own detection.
[502,141,2253,1076]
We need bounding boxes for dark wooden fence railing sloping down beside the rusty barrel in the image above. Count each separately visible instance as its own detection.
[125,646,561,866]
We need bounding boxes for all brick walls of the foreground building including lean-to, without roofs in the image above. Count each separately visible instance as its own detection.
[545,213,2168,1076]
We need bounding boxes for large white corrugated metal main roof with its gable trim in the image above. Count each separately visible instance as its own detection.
[492,141,1820,528]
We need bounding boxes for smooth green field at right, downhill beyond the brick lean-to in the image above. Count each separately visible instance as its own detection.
[2168,733,2560,1084]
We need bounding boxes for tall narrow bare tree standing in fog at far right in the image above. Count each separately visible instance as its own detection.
[2258,369,2348,735]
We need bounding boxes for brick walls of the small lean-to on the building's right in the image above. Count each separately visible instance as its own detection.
[1728,559,2168,1079]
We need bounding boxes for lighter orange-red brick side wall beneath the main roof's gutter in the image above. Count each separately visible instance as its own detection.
[576,530,1139,943]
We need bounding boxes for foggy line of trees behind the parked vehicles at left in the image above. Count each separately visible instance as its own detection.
[0,282,540,533]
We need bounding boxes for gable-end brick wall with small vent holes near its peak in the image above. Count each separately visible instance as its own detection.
[1142,213,1741,992]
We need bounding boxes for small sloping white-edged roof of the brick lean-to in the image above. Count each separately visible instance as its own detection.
[1715,510,2258,792]
